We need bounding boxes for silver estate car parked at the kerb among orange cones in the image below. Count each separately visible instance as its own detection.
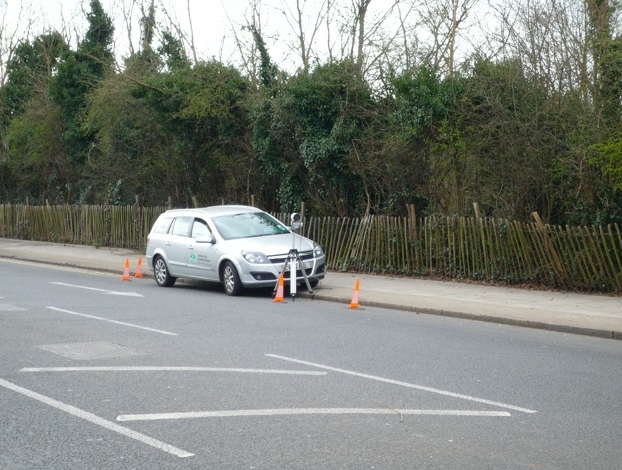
[146,205,326,295]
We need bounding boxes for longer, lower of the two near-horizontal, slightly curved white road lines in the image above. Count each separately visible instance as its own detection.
[117,408,511,421]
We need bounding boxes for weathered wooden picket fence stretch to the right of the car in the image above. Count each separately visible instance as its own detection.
[303,216,622,293]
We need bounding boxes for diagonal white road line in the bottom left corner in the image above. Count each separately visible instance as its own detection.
[0,379,194,458]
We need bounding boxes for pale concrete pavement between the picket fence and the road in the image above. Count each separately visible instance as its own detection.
[0,238,622,339]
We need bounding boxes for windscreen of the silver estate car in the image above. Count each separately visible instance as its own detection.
[212,212,289,240]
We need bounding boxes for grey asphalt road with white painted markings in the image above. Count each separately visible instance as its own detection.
[0,260,622,470]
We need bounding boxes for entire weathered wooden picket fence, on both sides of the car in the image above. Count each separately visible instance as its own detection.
[0,204,622,293]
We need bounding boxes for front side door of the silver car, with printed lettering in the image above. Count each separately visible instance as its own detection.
[187,217,219,281]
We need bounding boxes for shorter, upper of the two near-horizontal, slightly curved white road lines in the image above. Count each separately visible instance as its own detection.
[20,366,328,376]
